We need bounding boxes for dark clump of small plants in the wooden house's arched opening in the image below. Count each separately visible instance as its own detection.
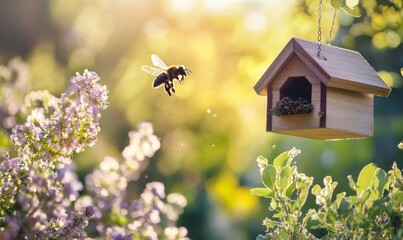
[270,97,314,117]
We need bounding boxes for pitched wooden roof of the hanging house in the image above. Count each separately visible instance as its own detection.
[254,38,391,97]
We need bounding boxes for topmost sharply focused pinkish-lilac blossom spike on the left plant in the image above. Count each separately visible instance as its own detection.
[11,70,108,159]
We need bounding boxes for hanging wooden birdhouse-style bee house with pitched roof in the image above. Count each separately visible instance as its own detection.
[254,38,390,140]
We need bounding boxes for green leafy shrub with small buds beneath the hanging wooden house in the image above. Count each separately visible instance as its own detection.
[251,148,403,240]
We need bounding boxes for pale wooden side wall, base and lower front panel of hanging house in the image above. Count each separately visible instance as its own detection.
[272,87,374,140]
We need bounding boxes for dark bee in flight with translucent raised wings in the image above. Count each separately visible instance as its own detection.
[141,54,192,97]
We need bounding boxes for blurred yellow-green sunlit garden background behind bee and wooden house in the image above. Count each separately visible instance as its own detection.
[0,0,403,240]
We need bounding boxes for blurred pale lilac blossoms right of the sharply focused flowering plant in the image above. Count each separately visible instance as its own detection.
[82,123,188,240]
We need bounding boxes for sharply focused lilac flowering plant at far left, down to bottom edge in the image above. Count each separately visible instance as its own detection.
[0,70,108,240]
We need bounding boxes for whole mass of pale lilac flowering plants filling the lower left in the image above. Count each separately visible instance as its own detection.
[0,61,187,240]
